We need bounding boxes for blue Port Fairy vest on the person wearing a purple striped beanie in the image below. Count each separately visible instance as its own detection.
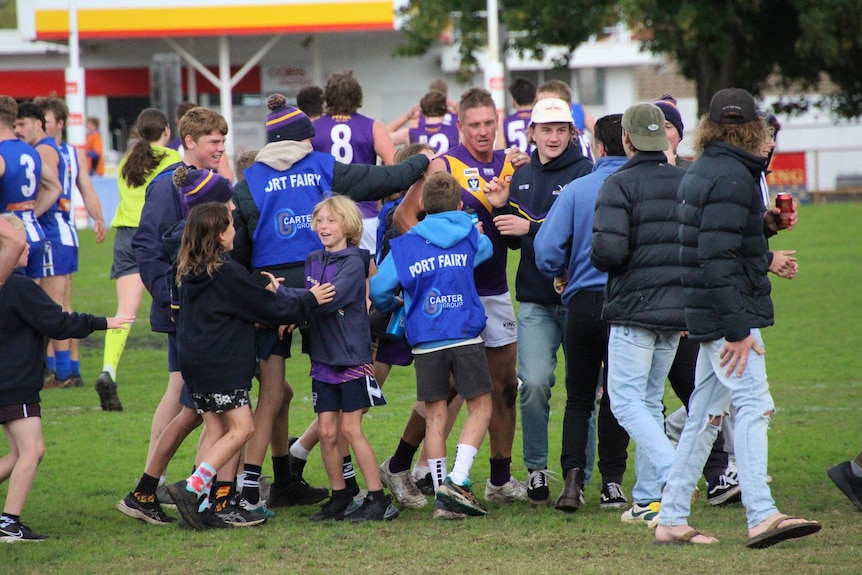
[245,152,335,268]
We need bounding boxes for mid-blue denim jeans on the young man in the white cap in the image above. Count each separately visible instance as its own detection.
[518,302,568,469]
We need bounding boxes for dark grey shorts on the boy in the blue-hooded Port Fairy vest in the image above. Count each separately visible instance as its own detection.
[413,343,494,401]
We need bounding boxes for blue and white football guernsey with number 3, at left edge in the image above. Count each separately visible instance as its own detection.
[0,139,45,246]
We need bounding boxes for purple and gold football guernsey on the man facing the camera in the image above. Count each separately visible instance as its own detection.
[440,145,514,296]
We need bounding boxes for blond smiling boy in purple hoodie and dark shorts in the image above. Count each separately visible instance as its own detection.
[279,196,398,523]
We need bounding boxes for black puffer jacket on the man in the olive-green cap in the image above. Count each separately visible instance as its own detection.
[590,152,685,330]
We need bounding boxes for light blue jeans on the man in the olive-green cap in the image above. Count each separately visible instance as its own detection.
[608,325,680,505]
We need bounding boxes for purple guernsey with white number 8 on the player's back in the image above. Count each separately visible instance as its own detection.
[311,114,379,218]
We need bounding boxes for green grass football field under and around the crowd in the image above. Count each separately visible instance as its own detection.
[0,204,862,575]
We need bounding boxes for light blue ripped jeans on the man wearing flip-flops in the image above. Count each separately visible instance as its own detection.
[659,329,778,528]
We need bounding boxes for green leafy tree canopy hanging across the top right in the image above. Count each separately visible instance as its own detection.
[400,0,862,117]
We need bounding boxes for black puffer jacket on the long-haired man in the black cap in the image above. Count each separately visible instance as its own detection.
[679,143,773,341]
